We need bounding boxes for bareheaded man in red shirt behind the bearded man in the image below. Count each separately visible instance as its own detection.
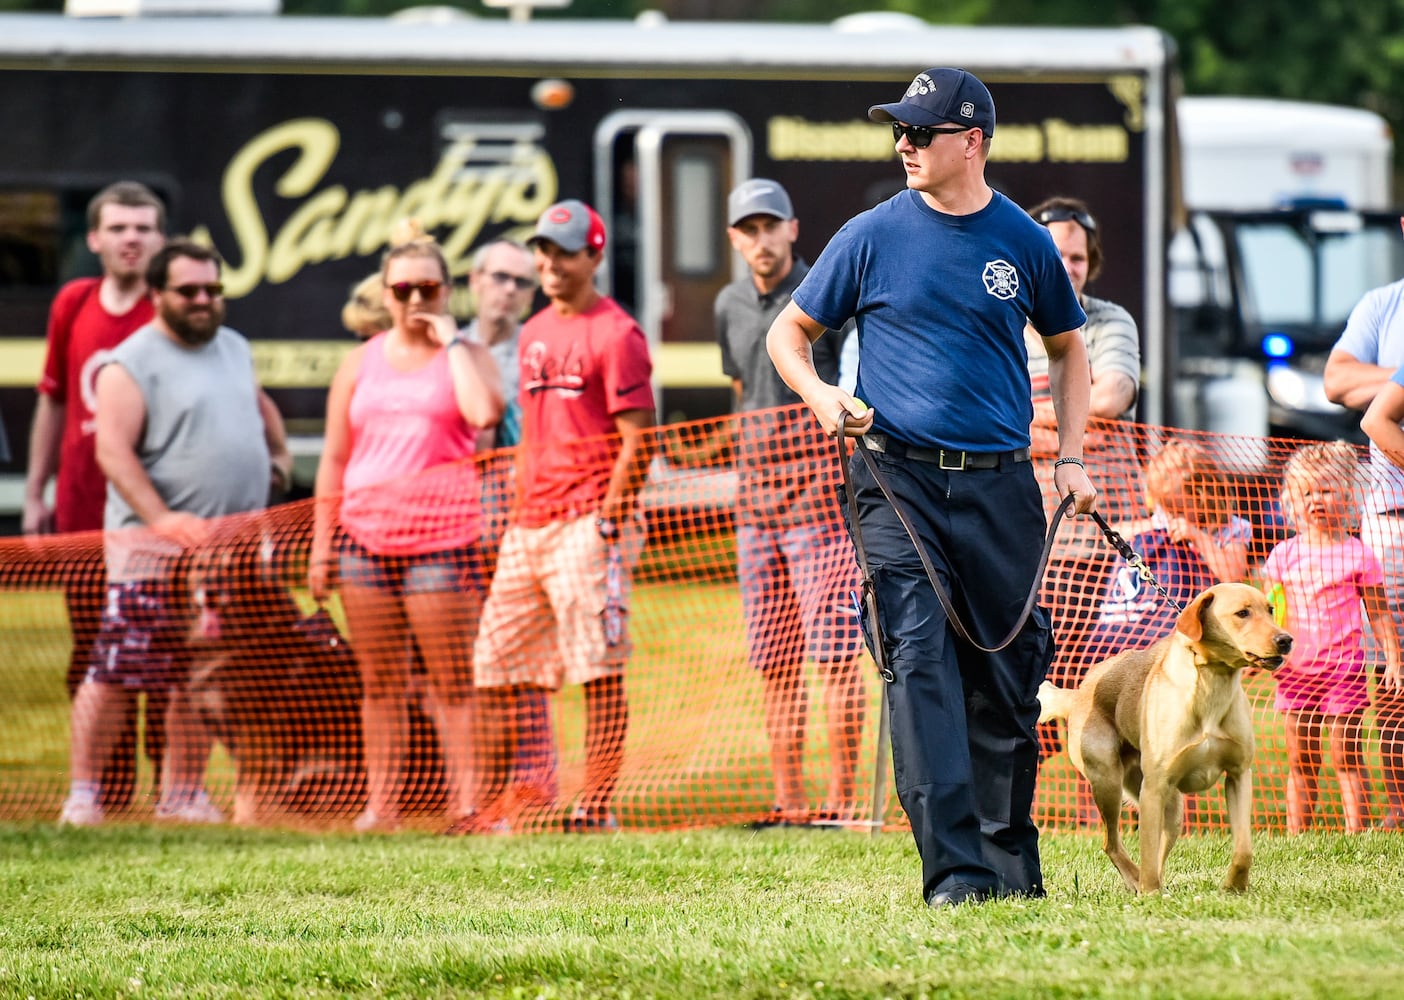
[24,181,166,808]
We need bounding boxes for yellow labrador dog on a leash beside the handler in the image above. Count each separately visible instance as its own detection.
[1039,583,1292,892]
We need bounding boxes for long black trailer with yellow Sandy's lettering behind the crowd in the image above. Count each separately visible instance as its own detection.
[0,5,1177,508]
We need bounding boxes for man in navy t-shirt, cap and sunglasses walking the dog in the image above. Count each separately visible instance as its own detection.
[768,62,1097,907]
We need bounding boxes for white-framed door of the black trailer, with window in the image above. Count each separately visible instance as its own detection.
[595,111,751,423]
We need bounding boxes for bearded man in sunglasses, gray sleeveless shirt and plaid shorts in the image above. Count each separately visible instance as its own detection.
[60,240,291,826]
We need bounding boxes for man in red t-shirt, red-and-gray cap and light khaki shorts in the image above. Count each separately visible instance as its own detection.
[463,199,653,833]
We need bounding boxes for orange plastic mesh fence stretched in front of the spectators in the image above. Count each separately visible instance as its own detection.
[0,410,1404,831]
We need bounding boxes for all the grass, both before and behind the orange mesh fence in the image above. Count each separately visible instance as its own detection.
[0,528,1404,1000]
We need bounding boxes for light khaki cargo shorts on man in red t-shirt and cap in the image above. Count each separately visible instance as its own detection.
[473,514,643,691]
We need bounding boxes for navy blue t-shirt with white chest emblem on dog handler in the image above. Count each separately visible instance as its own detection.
[793,191,1087,451]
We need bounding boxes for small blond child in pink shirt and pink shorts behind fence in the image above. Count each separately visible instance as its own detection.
[1262,441,1400,833]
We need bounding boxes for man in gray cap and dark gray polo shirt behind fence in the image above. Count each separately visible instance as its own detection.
[716,177,863,826]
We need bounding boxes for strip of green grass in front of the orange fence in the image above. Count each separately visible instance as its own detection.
[0,824,1404,1000]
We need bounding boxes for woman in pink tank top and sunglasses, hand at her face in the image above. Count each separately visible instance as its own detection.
[307,228,503,831]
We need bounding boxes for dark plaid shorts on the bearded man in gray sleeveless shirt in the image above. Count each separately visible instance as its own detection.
[87,580,190,691]
